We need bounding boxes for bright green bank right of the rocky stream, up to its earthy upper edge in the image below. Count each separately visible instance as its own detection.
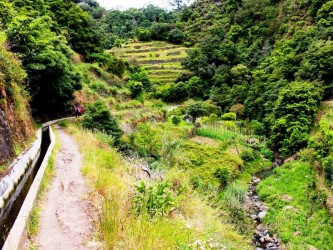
[254,101,333,249]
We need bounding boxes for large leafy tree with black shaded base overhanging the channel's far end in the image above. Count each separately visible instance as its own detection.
[7,15,81,114]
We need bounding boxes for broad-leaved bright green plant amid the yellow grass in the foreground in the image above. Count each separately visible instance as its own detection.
[133,182,180,217]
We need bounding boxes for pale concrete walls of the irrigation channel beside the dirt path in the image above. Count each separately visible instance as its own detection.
[0,117,72,250]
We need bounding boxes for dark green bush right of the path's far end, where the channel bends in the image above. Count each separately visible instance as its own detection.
[82,101,124,143]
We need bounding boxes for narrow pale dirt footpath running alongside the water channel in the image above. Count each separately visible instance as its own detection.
[36,128,93,250]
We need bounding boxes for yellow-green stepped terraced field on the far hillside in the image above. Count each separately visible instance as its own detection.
[113,41,188,84]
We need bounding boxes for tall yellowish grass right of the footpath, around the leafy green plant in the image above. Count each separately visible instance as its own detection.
[68,125,251,249]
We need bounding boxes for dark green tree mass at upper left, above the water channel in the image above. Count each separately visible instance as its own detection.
[0,0,121,116]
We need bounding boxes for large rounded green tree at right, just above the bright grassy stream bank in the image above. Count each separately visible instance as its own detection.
[269,82,322,156]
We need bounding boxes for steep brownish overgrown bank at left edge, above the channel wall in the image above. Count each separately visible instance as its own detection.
[0,33,34,166]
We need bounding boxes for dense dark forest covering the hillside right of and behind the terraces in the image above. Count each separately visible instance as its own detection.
[80,0,333,155]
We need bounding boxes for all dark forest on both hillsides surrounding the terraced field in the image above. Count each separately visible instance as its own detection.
[0,0,333,155]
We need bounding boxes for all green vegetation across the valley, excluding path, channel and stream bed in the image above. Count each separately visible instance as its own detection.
[0,0,333,249]
